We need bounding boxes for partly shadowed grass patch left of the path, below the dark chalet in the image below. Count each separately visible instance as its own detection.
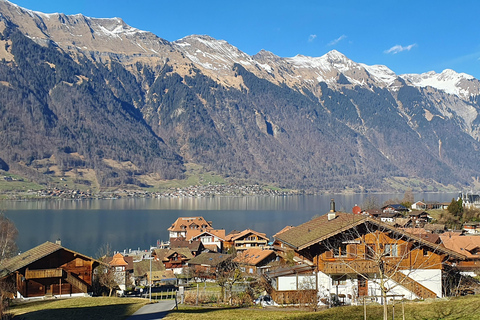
[9,297,148,320]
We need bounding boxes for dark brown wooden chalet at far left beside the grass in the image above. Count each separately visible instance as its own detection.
[0,242,101,298]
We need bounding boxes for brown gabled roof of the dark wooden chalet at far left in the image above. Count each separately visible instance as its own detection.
[0,241,102,276]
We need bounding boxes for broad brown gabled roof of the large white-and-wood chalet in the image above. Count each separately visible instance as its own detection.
[276,212,465,260]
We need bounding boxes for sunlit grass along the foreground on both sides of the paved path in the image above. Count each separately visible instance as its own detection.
[5,296,480,320]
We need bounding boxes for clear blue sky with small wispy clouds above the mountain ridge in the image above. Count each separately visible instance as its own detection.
[12,0,480,79]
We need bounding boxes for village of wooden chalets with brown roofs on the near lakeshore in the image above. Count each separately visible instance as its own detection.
[1,195,480,308]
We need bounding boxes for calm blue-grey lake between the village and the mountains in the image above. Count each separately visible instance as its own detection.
[0,193,457,256]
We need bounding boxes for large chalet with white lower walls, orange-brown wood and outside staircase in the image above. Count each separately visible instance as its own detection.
[275,203,465,303]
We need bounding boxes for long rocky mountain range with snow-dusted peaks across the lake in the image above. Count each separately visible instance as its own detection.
[0,0,480,191]
